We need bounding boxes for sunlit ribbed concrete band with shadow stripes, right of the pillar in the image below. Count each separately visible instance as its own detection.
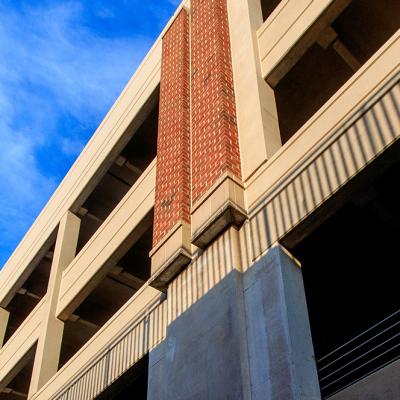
[251,76,400,258]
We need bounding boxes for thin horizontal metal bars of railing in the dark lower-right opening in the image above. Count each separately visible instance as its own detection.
[317,310,400,399]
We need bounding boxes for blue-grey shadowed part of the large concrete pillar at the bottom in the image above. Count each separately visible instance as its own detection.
[148,246,320,400]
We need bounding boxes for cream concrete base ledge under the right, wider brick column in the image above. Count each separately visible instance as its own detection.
[192,174,247,249]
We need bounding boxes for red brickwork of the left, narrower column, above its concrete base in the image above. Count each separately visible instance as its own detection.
[153,10,190,246]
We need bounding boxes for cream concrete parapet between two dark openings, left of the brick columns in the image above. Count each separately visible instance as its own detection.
[56,159,156,320]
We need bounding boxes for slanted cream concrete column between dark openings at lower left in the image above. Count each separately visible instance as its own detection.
[28,211,81,398]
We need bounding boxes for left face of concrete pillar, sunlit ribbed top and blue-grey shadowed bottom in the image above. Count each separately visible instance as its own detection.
[147,228,250,400]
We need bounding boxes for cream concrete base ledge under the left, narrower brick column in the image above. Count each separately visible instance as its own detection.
[149,221,192,291]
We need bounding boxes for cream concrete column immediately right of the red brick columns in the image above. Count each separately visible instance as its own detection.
[228,0,281,181]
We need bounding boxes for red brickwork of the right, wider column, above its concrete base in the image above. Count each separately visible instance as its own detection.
[191,0,241,204]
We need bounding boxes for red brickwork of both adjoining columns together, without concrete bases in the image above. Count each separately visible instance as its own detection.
[153,0,241,247]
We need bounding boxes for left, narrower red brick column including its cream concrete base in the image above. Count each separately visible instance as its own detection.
[150,9,191,288]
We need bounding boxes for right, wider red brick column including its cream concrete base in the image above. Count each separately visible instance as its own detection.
[191,0,245,247]
